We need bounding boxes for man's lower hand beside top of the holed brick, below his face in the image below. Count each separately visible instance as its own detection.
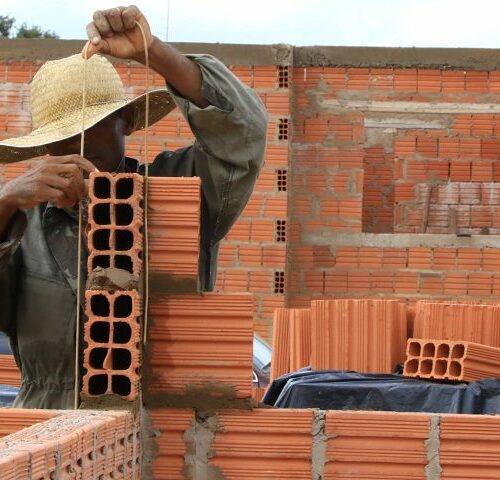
[0,155,95,210]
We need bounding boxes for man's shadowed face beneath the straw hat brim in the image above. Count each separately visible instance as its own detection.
[47,109,132,172]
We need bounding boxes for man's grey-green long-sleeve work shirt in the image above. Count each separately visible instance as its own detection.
[0,55,267,408]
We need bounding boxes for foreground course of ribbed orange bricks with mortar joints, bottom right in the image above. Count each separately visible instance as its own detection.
[150,408,500,480]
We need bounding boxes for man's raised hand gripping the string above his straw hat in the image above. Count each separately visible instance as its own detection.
[87,5,153,61]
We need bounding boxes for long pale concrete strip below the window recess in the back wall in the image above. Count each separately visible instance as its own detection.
[302,232,500,248]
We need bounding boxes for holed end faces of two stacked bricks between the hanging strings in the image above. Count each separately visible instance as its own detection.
[81,173,144,401]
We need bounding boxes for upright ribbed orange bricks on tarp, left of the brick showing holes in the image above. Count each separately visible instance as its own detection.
[271,299,408,379]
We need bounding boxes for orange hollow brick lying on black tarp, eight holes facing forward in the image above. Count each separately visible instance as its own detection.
[403,338,500,382]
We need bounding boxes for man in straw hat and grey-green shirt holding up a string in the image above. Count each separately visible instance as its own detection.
[0,6,267,408]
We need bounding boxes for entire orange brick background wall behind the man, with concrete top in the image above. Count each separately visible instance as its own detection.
[4,41,500,339]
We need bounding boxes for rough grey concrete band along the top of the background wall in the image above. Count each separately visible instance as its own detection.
[0,39,500,70]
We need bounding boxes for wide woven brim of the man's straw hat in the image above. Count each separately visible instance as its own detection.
[0,89,175,163]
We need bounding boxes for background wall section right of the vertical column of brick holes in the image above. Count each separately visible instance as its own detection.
[287,48,500,308]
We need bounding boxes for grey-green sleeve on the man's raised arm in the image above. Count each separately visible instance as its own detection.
[170,55,268,245]
